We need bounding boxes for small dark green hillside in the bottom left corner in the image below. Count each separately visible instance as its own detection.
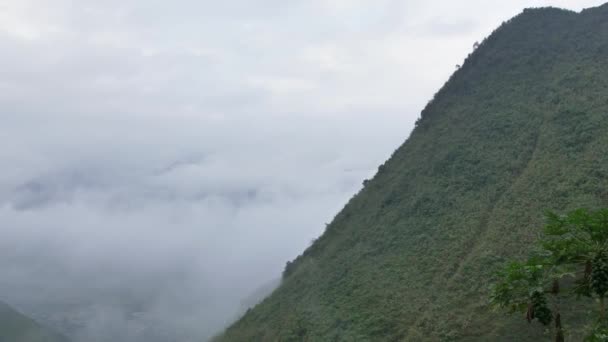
[0,302,69,342]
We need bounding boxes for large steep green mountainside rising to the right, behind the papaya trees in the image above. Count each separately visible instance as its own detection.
[218,5,608,341]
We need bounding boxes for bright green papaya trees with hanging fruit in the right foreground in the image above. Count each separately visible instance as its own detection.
[491,209,608,341]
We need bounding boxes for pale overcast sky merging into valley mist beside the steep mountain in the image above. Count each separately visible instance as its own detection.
[0,0,602,341]
